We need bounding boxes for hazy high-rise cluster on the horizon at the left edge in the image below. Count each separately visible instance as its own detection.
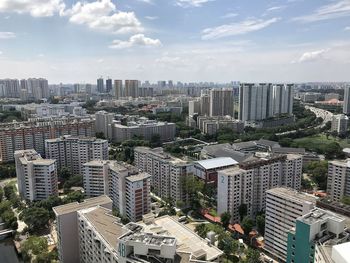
[0,78,51,100]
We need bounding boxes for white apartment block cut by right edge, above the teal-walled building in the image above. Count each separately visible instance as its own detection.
[327,160,350,201]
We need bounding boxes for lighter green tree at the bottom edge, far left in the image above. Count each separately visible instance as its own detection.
[21,236,48,262]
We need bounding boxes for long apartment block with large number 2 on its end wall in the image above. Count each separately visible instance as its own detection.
[217,154,302,222]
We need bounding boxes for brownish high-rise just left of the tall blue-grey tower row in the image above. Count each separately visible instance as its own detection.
[209,89,234,117]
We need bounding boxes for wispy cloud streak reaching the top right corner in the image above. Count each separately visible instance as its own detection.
[293,0,350,22]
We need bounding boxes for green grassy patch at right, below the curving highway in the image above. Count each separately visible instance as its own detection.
[292,134,350,151]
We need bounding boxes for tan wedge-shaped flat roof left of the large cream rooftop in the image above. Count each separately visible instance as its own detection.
[80,207,129,251]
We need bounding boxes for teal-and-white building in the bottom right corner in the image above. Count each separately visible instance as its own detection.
[287,208,350,263]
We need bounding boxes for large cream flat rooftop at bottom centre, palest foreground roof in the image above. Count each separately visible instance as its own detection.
[144,216,223,261]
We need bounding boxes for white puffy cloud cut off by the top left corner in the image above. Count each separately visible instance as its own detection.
[0,0,65,17]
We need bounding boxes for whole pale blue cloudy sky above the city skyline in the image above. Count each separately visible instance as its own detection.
[0,0,350,83]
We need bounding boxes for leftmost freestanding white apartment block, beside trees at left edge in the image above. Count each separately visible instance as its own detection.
[14,150,58,201]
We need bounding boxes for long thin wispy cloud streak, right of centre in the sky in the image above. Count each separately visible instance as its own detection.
[202,17,279,40]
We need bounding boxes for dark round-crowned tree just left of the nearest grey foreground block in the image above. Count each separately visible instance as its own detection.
[20,206,50,232]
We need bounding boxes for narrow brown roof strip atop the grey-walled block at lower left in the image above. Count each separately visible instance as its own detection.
[52,195,112,216]
